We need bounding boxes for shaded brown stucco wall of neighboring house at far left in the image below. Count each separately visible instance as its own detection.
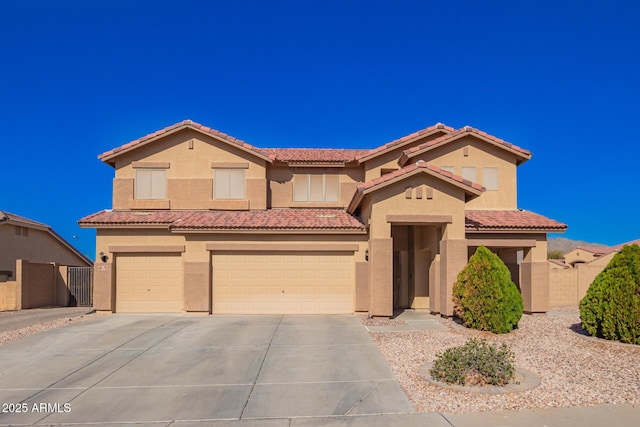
[0,224,87,280]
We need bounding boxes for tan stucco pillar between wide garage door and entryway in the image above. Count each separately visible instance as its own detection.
[369,238,393,316]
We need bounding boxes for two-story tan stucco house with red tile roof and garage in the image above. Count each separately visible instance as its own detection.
[80,120,566,316]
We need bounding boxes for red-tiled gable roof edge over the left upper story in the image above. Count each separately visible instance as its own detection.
[98,120,274,166]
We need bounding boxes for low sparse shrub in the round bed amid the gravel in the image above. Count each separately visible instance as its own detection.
[429,338,516,386]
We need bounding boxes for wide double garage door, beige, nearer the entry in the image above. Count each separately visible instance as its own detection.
[212,252,354,314]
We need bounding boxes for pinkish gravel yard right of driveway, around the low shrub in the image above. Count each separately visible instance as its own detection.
[371,307,640,413]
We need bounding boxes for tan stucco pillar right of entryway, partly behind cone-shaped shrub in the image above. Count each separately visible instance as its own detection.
[440,239,467,316]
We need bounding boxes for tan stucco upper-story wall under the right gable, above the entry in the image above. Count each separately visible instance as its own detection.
[409,136,517,209]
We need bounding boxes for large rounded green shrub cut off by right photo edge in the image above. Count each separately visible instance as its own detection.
[580,244,640,344]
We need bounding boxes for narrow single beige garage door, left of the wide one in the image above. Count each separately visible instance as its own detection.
[116,254,182,313]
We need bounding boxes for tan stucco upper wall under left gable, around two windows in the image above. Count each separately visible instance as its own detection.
[113,129,267,210]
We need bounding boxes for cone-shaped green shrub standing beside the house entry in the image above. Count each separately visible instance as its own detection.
[453,246,524,334]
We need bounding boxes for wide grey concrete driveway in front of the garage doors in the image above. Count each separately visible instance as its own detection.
[0,315,413,424]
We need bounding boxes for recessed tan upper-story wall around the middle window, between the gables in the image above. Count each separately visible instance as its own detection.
[267,163,364,208]
